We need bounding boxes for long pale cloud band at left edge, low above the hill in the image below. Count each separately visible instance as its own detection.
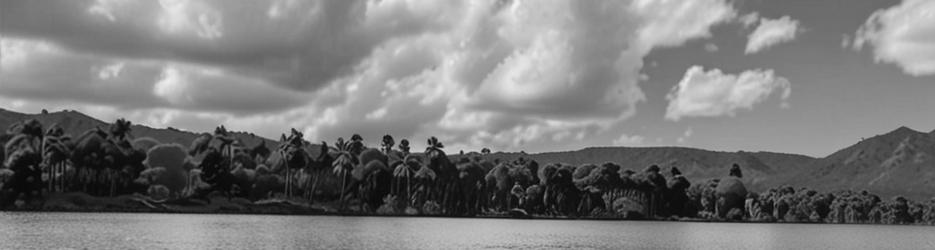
[0,38,304,114]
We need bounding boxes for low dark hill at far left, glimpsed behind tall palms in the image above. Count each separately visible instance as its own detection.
[0,109,279,149]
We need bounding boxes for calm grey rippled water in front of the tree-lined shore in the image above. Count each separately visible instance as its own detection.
[0,212,935,249]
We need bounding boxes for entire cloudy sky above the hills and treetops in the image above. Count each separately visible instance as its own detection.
[0,0,935,157]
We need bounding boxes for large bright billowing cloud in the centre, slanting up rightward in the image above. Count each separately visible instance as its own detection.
[254,1,734,152]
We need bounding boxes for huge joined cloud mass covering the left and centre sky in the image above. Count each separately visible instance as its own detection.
[0,0,736,151]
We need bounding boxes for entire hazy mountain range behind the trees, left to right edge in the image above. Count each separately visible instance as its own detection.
[0,109,935,199]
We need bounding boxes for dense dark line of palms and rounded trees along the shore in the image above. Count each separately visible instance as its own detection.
[0,119,935,224]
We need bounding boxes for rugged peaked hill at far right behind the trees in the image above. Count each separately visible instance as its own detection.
[790,127,935,199]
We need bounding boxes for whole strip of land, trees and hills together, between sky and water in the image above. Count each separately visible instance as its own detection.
[0,110,935,225]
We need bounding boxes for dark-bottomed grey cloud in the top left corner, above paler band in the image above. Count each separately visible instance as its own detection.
[0,0,386,91]
